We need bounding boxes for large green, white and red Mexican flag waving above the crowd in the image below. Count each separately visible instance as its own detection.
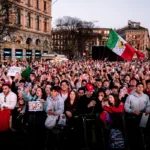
[106,29,136,61]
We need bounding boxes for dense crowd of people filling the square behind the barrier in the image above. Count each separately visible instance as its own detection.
[0,60,150,150]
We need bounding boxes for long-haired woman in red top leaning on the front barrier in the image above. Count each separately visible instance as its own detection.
[103,94,125,148]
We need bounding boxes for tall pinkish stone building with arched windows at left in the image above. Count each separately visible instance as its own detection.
[1,0,52,60]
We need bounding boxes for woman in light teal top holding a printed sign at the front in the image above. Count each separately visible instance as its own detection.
[24,88,46,150]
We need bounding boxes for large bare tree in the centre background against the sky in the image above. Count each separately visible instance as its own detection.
[56,16,94,57]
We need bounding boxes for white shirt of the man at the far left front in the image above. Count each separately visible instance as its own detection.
[0,92,17,109]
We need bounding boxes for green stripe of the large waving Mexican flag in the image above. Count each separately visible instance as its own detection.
[106,29,119,50]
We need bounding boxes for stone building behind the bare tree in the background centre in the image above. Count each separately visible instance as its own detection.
[52,28,110,57]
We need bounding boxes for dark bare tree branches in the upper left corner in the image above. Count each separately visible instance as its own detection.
[0,0,16,43]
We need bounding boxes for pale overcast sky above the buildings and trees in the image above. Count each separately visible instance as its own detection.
[52,0,150,30]
